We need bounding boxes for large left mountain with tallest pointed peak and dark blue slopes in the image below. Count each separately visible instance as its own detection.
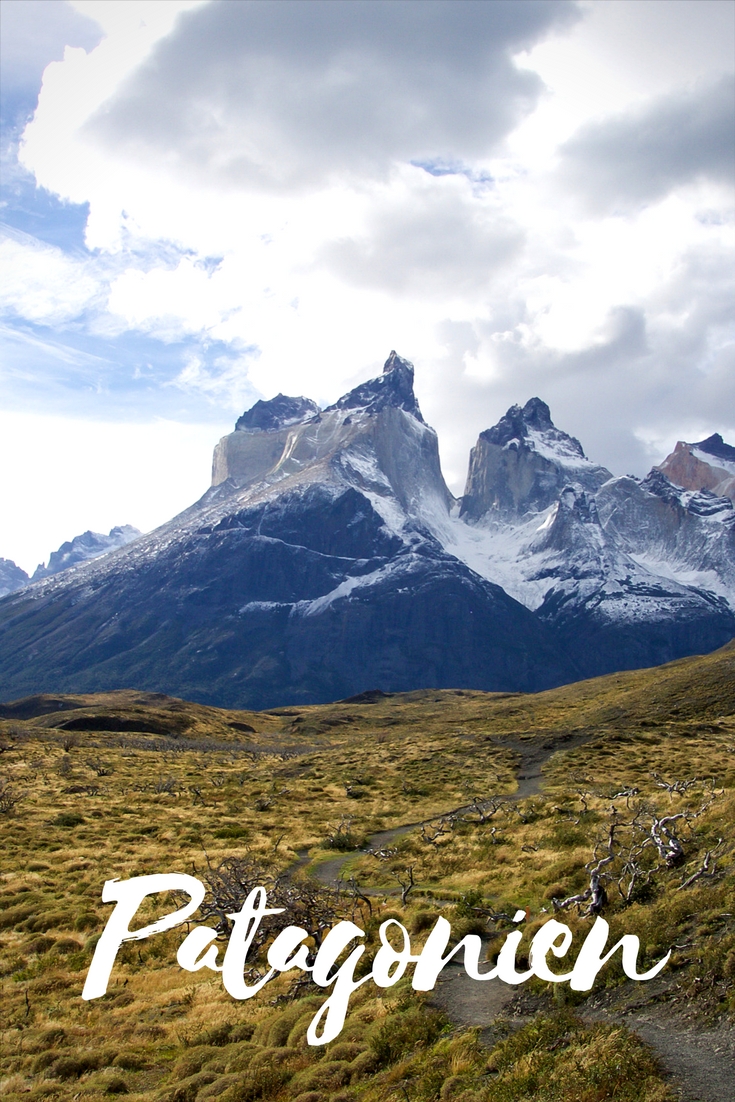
[0,355,576,707]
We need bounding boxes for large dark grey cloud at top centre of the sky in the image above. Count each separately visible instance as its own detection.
[90,0,580,190]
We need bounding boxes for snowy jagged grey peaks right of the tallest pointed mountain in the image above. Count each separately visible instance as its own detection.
[446,399,735,676]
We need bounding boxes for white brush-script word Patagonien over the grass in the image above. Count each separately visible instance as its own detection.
[82,873,671,1045]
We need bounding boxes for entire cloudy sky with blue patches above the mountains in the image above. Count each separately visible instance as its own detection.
[0,0,735,570]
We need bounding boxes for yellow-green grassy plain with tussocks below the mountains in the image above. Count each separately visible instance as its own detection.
[0,644,735,1102]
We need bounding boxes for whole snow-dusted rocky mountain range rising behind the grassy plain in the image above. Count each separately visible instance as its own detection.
[0,353,735,709]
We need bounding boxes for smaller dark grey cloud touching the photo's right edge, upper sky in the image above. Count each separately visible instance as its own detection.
[561,76,735,213]
